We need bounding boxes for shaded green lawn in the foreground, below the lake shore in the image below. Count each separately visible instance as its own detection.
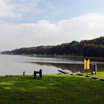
[0,75,104,104]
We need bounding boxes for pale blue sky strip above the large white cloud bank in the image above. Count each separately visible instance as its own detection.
[3,0,104,23]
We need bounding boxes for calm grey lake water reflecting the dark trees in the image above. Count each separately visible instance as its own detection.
[0,55,104,76]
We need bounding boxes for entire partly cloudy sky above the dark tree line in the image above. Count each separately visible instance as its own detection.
[0,0,104,51]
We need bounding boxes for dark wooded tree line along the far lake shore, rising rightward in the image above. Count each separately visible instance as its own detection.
[1,37,104,57]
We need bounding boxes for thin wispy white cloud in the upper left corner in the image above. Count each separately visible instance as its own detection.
[0,0,43,19]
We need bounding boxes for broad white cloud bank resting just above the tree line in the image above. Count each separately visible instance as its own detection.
[0,13,104,50]
